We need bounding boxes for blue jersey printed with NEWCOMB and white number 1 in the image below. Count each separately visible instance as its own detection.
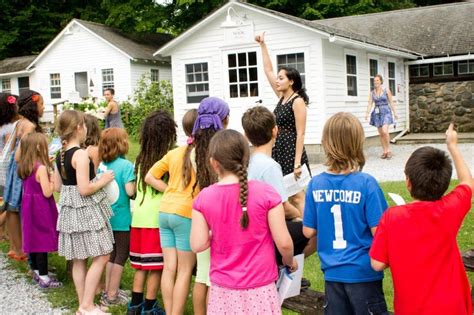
[303,172,387,283]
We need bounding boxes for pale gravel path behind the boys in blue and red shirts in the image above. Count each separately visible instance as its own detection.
[311,143,474,182]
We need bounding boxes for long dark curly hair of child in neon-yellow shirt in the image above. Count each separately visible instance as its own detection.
[135,110,177,204]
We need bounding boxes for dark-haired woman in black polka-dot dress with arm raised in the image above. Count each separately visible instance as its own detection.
[255,32,309,213]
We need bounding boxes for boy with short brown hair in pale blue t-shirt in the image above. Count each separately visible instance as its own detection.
[242,106,316,272]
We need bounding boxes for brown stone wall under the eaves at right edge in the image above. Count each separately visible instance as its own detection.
[410,81,474,132]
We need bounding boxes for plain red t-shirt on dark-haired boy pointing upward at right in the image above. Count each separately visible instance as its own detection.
[369,185,472,315]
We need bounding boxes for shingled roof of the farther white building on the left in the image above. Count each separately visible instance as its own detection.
[74,19,173,61]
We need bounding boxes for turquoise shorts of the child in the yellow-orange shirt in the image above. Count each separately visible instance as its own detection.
[160,212,191,252]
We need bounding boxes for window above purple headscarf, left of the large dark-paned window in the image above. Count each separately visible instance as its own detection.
[186,62,209,103]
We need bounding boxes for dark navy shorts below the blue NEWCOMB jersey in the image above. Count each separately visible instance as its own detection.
[324,280,389,315]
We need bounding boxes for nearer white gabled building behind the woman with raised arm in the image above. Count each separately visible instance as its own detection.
[155,1,418,155]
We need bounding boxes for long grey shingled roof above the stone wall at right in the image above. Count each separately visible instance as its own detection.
[312,2,474,57]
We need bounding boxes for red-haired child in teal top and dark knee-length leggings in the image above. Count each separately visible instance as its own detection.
[99,127,135,306]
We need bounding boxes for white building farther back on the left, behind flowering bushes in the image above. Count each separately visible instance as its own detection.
[0,19,171,121]
